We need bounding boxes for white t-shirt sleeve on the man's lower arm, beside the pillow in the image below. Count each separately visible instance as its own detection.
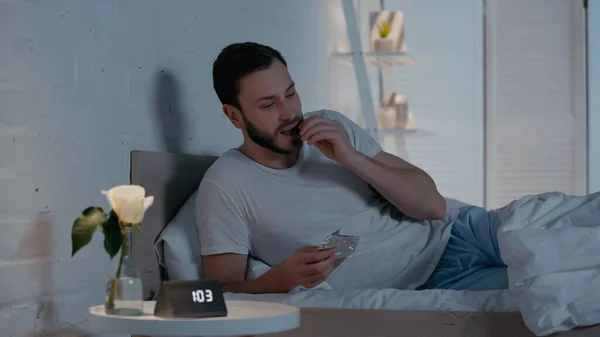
[196,180,250,255]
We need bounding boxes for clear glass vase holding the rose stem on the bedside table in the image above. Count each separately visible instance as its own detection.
[104,229,144,316]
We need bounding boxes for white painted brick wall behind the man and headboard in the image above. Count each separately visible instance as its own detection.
[0,0,327,337]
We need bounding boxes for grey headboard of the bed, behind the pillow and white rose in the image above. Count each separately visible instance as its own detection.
[130,151,218,300]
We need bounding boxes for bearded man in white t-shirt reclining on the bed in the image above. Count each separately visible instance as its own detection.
[197,42,507,293]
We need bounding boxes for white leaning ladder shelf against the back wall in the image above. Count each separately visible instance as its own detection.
[330,0,434,160]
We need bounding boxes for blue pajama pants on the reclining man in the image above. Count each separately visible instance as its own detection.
[418,206,508,290]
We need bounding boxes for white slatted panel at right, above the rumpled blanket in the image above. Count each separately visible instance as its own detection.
[486,0,586,208]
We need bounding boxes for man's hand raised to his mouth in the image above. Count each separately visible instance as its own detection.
[299,116,358,165]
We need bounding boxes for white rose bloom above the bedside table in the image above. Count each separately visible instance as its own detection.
[100,185,154,225]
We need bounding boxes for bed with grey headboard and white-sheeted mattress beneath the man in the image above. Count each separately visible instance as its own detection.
[130,151,600,337]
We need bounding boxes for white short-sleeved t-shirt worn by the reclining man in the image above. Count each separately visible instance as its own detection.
[196,110,456,289]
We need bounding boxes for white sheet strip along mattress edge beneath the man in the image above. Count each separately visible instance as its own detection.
[225,289,519,312]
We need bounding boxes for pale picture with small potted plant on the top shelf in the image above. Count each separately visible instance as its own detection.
[369,11,406,52]
